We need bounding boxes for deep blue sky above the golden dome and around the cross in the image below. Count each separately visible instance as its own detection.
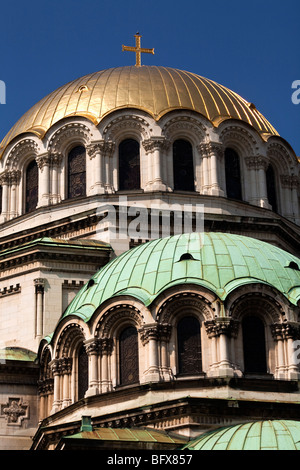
[0,0,300,156]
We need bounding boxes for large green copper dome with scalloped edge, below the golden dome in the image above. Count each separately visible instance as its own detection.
[63,233,300,321]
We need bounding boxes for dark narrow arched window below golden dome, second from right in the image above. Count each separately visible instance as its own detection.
[225,148,242,201]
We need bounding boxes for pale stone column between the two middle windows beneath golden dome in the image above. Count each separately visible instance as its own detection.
[143,137,167,191]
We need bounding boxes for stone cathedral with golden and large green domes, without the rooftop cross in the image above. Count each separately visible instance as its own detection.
[0,57,300,449]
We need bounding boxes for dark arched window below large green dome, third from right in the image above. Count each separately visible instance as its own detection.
[119,326,139,385]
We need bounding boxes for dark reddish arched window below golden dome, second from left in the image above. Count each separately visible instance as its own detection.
[68,145,86,199]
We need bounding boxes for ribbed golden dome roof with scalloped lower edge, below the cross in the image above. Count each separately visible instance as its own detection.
[0,65,278,153]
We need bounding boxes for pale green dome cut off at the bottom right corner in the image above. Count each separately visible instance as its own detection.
[184,420,300,450]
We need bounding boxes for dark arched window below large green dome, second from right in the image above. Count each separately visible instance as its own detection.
[177,317,202,375]
